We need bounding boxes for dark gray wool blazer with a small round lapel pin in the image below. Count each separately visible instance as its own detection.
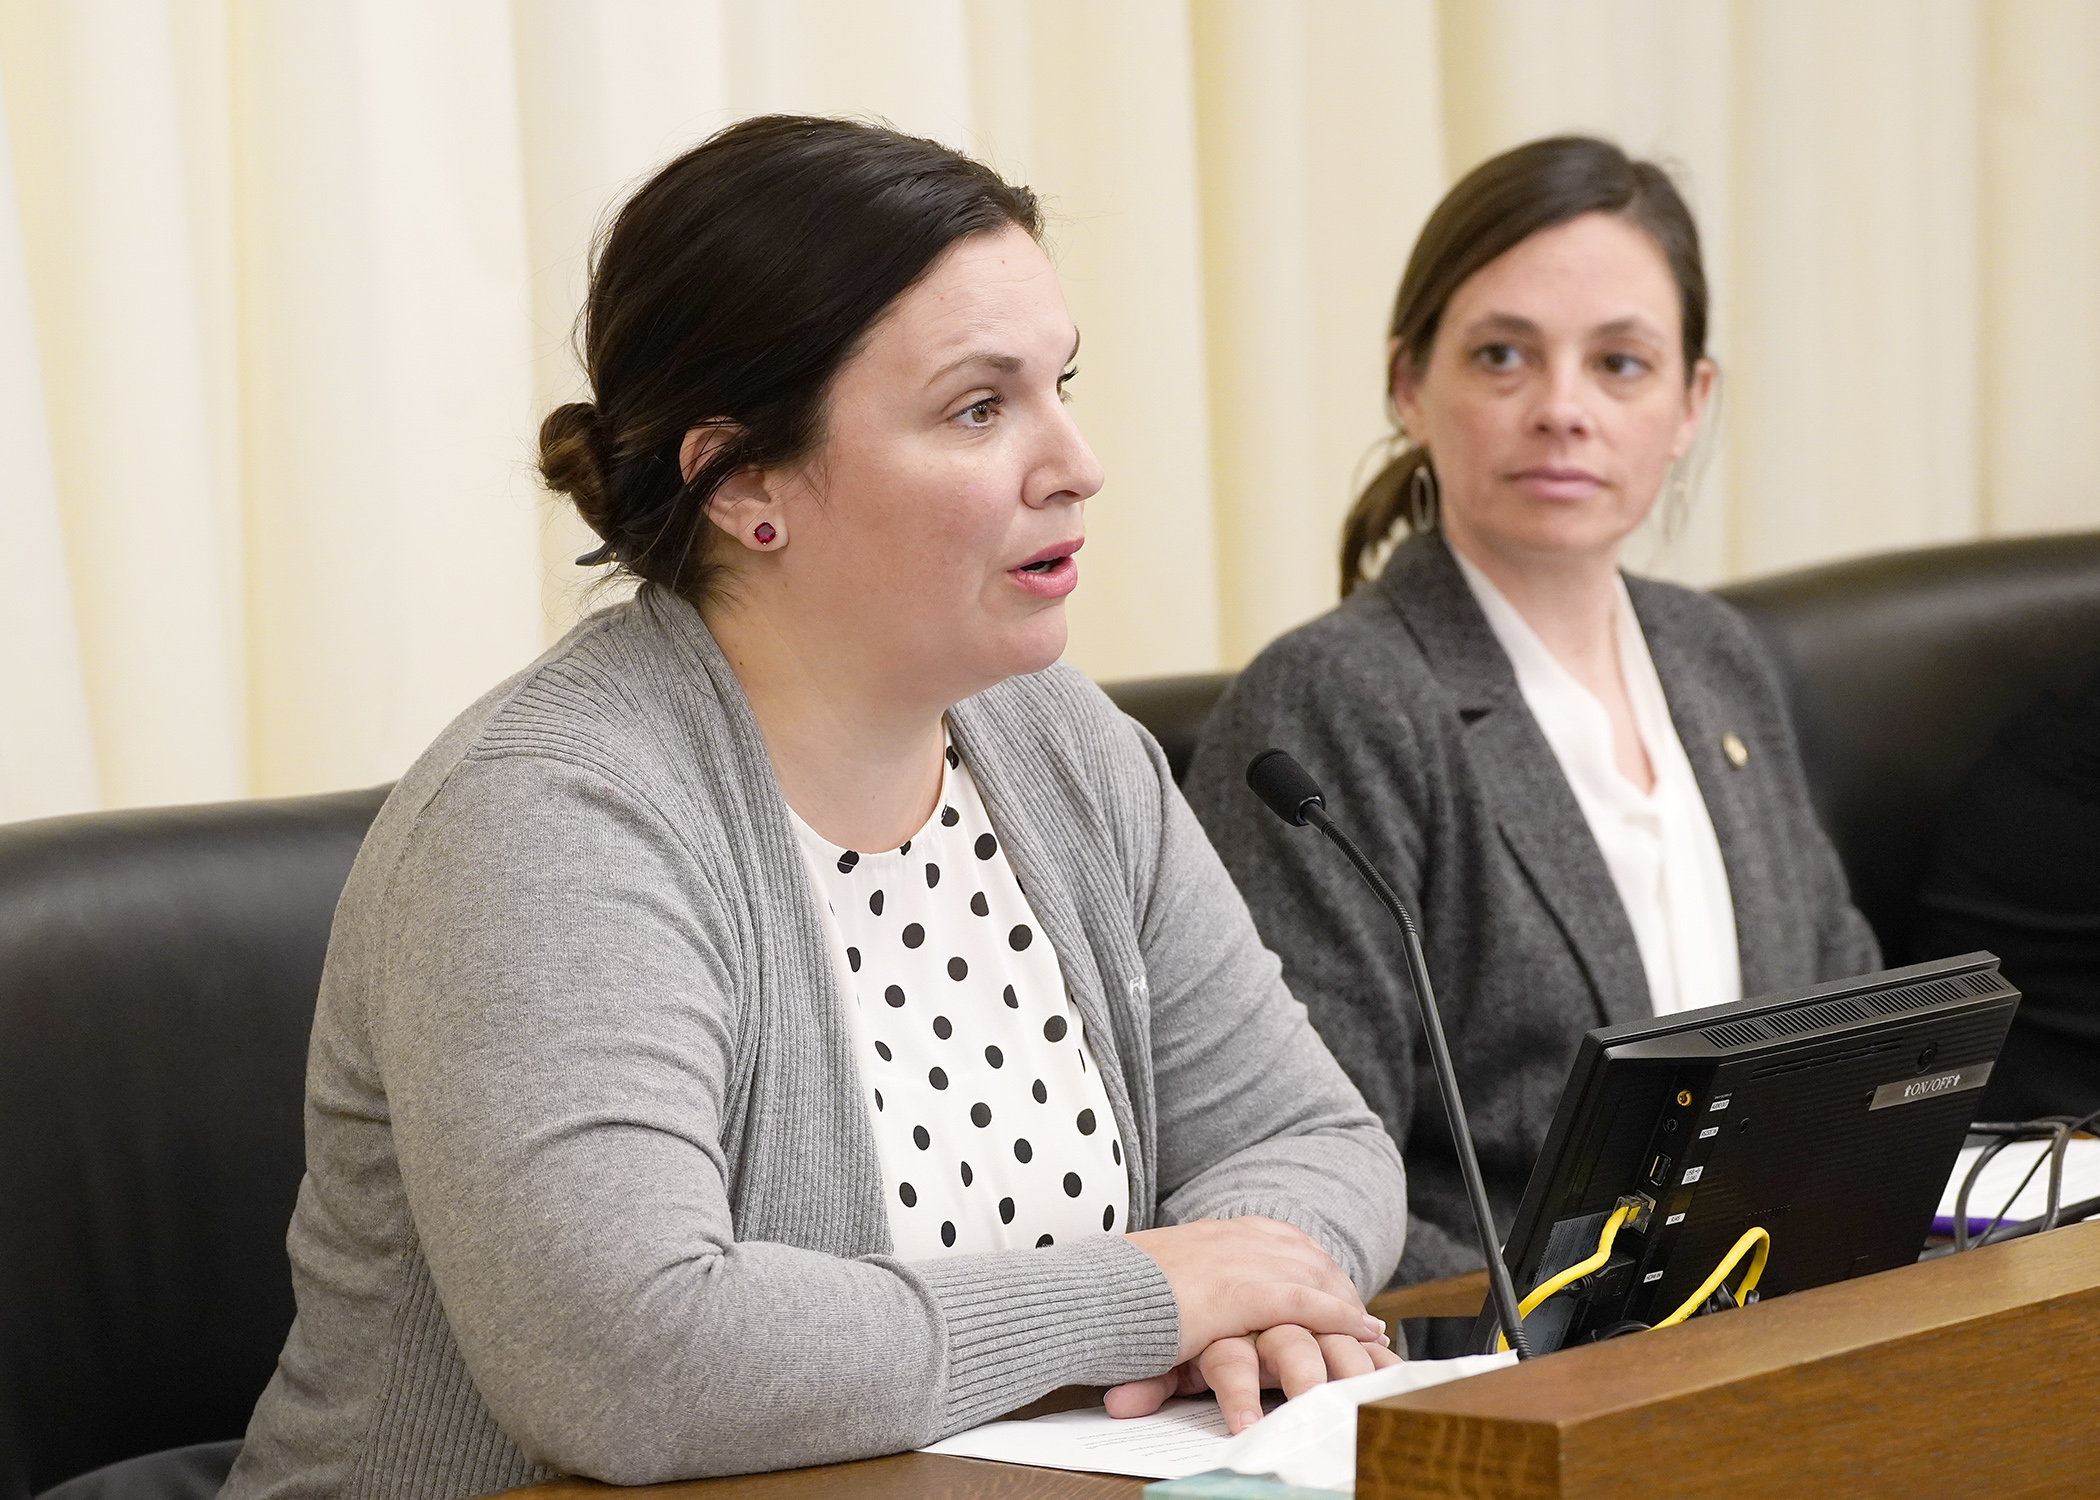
[1187,536,1880,1282]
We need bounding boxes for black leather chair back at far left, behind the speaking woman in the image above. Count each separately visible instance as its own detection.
[0,788,384,1496]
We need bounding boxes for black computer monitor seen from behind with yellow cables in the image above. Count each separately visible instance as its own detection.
[1474,954,2020,1353]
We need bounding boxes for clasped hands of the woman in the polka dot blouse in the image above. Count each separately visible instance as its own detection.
[1107,1216,1401,1433]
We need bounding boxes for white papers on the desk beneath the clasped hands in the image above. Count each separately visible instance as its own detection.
[922,1353,1516,1492]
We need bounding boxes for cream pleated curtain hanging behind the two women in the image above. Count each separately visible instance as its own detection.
[0,0,2100,819]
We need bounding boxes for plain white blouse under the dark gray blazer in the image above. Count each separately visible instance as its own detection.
[1451,548,1743,1015]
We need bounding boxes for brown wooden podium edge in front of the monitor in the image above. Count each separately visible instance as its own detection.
[1357,1223,2100,1500]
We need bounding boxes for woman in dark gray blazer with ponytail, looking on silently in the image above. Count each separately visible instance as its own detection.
[1187,139,1877,1319]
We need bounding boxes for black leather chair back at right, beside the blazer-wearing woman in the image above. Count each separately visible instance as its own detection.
[1716,532,2100,964]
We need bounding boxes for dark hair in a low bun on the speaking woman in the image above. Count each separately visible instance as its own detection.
[540,116,1042,605]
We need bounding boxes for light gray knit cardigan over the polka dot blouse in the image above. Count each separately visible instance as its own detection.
[225,588,1405,1500]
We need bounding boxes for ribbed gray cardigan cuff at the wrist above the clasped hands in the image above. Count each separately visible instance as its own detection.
[911,1235,1180,1435]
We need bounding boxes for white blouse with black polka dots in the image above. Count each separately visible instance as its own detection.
[790,746,1130,1261]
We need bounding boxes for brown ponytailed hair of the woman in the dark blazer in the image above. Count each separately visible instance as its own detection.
[1342,134,1707,597]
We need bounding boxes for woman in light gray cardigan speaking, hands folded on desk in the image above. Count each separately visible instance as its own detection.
[225,118,1405,1500]
